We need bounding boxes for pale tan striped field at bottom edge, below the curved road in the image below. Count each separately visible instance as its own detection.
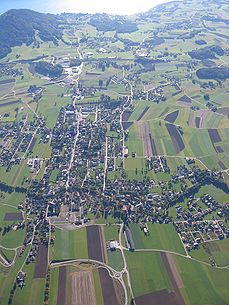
[72,271,96,305]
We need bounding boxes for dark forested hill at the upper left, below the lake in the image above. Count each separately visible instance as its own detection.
[0,9,62,58]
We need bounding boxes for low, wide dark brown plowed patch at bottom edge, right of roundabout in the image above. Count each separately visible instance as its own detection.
[135,289,178,305]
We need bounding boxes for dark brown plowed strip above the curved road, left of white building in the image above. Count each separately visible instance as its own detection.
[87,226,105,262]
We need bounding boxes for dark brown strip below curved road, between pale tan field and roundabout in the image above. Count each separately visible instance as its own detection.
[99,268,119,305]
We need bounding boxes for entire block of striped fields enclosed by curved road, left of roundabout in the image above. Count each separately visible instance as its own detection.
[49,264,123,305]
